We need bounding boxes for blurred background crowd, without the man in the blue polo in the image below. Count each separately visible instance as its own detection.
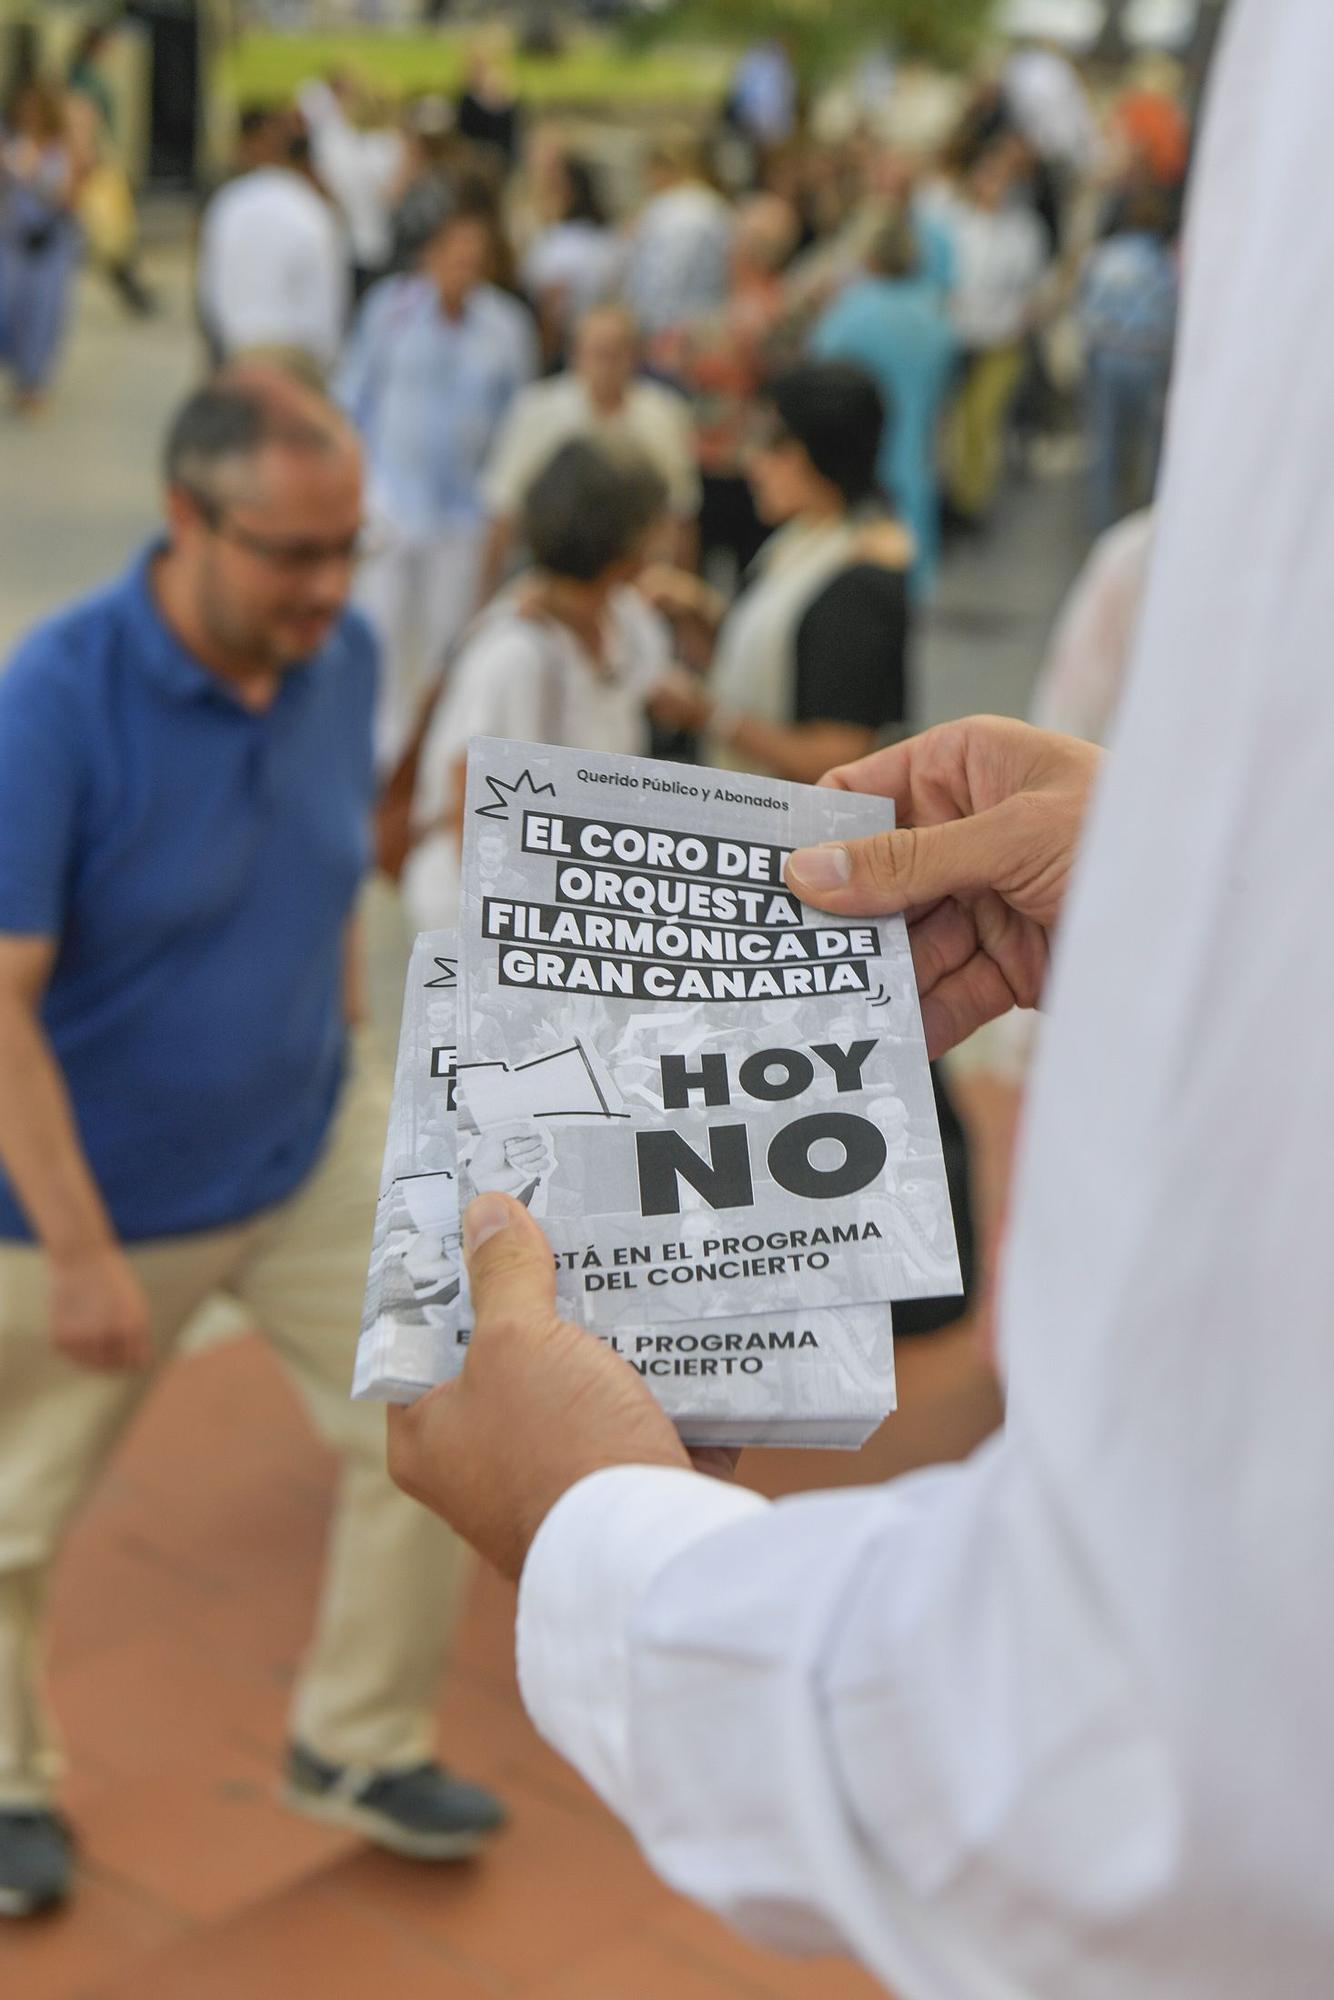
[117,44,1188,908]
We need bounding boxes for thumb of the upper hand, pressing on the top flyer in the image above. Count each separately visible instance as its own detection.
[784,800,1020,916]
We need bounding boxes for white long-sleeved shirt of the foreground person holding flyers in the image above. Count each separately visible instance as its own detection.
[518,0,1334,2000]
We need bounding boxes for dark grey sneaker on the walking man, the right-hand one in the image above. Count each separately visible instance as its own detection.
[282,1744,506,1862]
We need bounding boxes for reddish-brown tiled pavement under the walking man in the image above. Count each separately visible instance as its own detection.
[0,1092,1004,2000]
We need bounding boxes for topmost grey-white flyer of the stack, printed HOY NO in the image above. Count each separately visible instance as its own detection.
[458,738,962,1344]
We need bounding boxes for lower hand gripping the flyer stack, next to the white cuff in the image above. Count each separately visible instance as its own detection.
[388,1194,708,1576]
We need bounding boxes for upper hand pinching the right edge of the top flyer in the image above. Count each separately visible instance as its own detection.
[786,716,1102,1058]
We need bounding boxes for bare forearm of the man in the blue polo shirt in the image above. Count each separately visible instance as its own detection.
[0,994,116,1258]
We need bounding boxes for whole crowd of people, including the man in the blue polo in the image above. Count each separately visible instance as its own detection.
[0,34,1190,1914]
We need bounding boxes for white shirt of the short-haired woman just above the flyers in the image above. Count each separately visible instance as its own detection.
[402,580,672,930]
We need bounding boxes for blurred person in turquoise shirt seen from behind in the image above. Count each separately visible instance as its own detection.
[812,216,956,598]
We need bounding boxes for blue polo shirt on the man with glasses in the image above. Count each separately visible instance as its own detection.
[0,550,376,1242]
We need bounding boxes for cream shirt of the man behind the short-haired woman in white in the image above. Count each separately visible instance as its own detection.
[482,374,700,516]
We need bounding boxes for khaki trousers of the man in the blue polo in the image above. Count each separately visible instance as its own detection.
[0,1050,462,1806]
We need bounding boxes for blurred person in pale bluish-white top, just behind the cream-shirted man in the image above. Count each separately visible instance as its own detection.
[626,142,734,340]
